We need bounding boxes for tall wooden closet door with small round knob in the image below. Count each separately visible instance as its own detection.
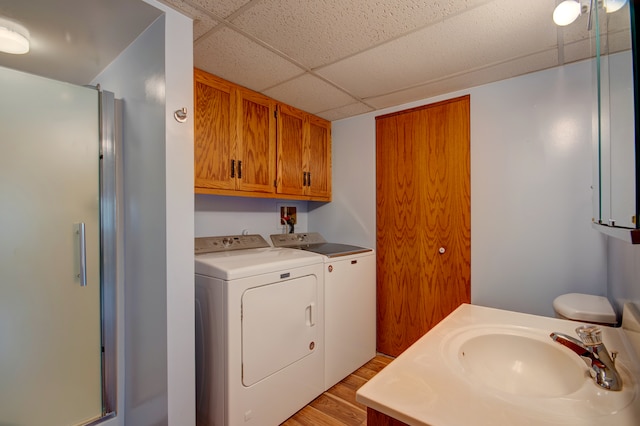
[376,96,471,356]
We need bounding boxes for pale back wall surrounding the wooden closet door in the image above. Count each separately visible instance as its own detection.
[309,62,607,316]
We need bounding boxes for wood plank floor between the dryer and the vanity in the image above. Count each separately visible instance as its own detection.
[281,355,393,426]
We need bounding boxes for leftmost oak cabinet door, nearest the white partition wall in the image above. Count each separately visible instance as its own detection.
[194,69,237,189]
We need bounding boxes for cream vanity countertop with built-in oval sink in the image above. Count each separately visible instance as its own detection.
[356,305,640,426]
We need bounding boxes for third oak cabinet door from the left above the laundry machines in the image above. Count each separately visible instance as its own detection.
[277,104,308,195]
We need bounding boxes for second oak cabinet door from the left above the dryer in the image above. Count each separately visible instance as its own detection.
[236,89,276,192]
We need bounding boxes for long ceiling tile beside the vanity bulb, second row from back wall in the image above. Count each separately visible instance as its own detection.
[316,0,557,98]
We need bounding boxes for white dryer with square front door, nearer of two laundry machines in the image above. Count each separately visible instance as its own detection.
[195,235,324,426]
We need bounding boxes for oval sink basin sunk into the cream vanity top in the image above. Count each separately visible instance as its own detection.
[452,330,586,397]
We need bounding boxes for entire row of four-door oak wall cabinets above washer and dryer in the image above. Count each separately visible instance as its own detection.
[194,69,331,201]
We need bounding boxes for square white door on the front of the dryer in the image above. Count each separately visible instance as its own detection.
[242,275,320,386]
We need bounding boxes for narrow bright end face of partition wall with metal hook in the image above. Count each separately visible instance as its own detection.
[157,0,196,426]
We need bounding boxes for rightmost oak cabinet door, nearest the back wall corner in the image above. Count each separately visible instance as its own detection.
[305,116,331,197]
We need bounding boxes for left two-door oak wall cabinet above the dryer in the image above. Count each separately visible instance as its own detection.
[194,69,276,195]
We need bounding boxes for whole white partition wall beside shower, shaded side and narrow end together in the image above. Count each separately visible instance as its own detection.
[94,0,195,425]
